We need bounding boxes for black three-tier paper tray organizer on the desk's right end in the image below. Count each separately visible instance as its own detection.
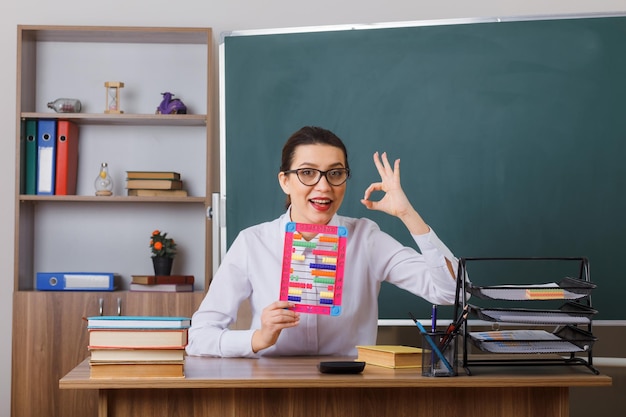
[454,258,599,375]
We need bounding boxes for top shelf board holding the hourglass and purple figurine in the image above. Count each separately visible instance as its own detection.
[21,112,207,126]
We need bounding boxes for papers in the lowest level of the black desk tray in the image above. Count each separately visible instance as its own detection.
[469,326,596,353]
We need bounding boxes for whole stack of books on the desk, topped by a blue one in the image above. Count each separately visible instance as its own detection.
[87,316,191,378]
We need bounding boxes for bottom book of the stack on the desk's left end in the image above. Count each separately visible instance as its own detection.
[89,361,185,379]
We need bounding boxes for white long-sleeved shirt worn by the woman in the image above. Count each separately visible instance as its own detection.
[187,212,458,357]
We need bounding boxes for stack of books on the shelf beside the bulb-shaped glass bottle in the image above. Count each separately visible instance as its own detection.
[126,171,187,197]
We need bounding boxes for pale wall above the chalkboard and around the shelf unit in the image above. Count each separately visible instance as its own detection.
[0,0,626,417]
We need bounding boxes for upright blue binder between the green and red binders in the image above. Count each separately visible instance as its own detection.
[37,119,57,195]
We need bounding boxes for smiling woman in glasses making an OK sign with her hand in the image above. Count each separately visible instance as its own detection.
[187,127,457,357]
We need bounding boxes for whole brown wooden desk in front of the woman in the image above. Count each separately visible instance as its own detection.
[59,357,612,417]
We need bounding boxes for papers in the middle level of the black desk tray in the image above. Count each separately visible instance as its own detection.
[469,302,597,325]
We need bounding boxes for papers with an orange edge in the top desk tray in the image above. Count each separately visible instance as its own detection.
[468,277,596,301]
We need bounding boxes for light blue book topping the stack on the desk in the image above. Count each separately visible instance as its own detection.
[87,316,191,329]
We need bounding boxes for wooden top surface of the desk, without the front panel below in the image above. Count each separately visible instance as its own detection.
[59,356,612,389]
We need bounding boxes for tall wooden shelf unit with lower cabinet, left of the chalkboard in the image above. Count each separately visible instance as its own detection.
[11,25,214,417]
